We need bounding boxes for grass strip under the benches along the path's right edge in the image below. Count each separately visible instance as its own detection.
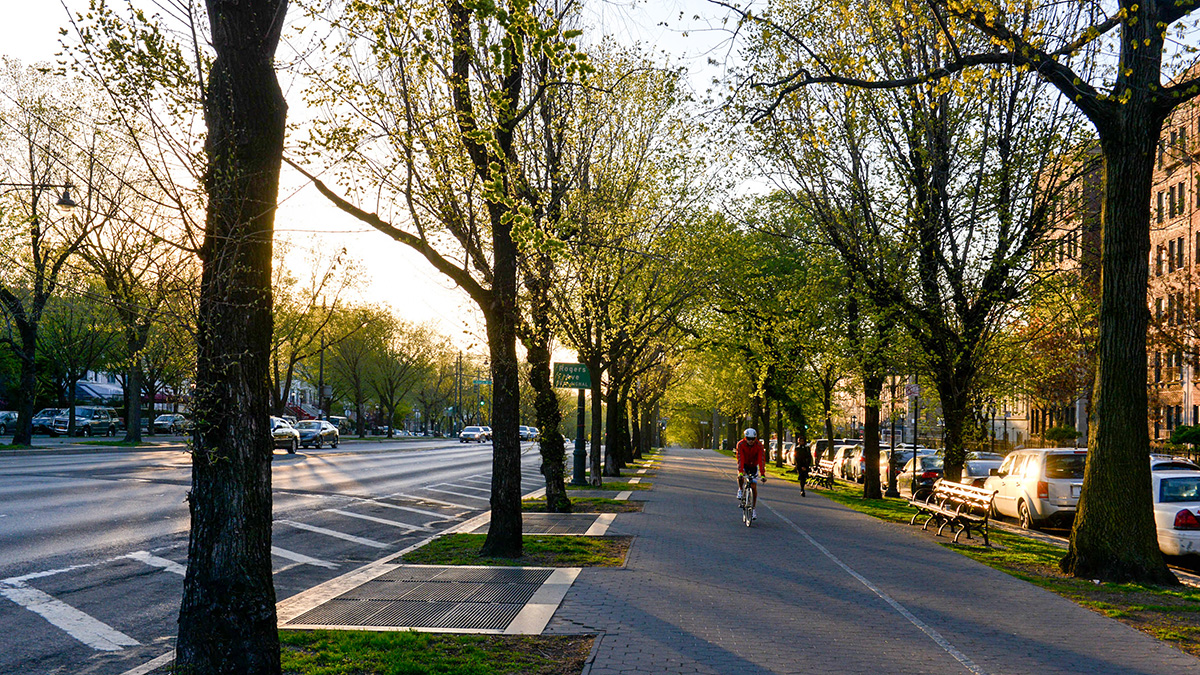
[768,458,1200,656]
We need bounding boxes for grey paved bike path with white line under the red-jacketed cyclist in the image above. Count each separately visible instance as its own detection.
[546,448,1200,675]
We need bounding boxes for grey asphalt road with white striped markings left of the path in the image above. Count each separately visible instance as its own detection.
[0,440,542,675]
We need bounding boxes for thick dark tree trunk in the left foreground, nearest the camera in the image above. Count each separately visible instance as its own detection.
[175,0,287,675]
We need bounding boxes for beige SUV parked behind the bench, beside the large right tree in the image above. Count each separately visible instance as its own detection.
[984,448,1087,530]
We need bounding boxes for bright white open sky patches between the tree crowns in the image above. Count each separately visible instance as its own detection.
[0,0,724,354]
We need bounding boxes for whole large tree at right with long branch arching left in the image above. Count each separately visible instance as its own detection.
[715,0,1200,585]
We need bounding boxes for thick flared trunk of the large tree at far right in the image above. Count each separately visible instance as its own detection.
[1061,106,1178,585]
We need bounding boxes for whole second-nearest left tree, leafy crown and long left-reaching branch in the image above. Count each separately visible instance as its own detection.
[295,0,586,557]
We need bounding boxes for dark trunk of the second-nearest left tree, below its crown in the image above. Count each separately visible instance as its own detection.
[481,199,522,557]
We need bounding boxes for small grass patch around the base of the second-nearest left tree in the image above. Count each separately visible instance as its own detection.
[404,534,631,567]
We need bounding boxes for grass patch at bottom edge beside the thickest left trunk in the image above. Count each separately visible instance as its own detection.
[280,631,594,675]
